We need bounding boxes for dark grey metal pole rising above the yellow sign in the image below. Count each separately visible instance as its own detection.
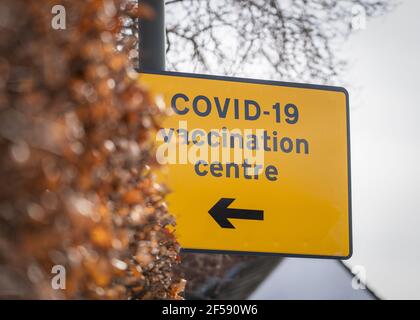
[138,0,166,72]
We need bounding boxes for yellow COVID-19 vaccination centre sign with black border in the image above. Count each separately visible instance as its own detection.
[140,72,352,259]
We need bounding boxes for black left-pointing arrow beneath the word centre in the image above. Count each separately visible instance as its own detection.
[209,198,264,229]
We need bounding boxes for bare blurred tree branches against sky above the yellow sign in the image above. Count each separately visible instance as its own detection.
[166,0,393,83]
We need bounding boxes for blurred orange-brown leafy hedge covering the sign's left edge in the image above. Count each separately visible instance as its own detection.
[0,0,184,299]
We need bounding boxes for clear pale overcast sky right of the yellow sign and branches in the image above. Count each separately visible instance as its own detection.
[343,0,420,299]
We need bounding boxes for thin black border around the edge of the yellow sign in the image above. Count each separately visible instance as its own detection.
[140,70,353,260]
